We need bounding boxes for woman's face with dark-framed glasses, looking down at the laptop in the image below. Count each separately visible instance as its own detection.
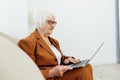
[44,17,56,35]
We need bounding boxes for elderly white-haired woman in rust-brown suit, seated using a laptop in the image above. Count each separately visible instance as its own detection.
[19,11,93,80]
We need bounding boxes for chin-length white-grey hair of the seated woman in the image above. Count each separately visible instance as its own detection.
[33,11,55,28]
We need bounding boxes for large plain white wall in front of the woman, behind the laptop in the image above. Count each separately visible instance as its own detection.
[29,0,116,64]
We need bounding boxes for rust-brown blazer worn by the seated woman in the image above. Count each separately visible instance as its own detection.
[18,29,67,79]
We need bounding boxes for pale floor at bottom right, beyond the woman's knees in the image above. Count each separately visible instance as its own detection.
[93,64,120,80]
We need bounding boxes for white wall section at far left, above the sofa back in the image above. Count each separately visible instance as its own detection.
[0,0,28,38]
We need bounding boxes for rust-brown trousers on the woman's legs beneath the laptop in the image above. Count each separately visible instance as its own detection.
[47,64,93,80]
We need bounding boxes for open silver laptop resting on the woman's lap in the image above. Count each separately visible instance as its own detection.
[66,42,104,68]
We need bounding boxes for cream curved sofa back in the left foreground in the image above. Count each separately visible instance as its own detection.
[0,35,45,80]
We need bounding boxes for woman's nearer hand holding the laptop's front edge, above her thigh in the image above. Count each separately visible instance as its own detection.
[49,65,73,77]
